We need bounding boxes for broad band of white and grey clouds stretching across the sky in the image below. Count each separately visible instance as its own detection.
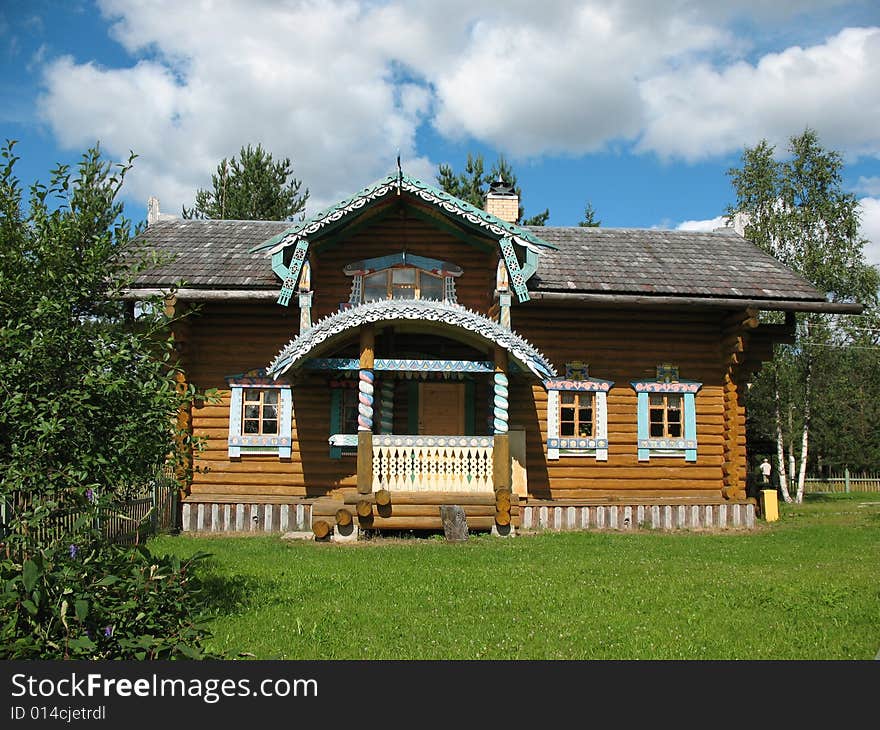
[31,0,880,210]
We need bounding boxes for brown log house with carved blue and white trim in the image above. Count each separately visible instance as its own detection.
[128,173,859,537]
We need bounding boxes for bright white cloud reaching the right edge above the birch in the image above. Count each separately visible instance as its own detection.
[638,28,880,161]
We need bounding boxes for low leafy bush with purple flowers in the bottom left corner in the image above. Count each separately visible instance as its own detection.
[0,542,217,659]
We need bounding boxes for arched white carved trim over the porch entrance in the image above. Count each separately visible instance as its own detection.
[267,299,556,381]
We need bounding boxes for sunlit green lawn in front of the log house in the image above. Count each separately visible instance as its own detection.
[151,494,880,660]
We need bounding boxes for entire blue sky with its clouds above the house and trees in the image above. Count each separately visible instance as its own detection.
[0,0,880,263]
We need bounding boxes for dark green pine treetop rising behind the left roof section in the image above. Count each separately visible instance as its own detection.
[182,144,309,221]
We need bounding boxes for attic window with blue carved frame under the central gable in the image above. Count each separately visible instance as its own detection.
[344,252,462,306]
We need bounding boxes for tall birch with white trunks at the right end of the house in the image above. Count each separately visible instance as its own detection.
[727,129,878,502]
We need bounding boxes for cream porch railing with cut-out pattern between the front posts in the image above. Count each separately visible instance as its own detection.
[373,435,494,492]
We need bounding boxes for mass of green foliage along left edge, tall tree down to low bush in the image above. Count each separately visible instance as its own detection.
[0,142,217,658]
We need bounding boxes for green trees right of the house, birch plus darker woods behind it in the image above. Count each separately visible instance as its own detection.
[728,129,880,498]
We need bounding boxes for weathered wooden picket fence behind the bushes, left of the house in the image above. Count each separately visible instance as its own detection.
[0,477,179,545]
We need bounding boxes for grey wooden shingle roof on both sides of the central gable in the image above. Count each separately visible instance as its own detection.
[124,220,844,308]
